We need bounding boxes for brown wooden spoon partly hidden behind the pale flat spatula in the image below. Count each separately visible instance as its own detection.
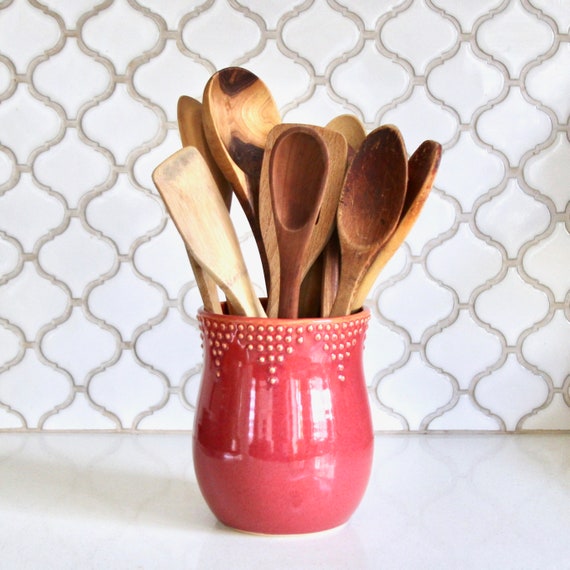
[177,95,232,313]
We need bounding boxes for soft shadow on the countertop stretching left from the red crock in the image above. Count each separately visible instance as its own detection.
[0,438,216,531]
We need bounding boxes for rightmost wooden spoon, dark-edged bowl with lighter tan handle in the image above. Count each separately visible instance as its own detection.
[351,140,441,311]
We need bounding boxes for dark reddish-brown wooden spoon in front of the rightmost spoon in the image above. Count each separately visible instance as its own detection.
[331,125,408,317]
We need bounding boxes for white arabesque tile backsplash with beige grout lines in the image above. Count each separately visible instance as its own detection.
[0,0,570,432]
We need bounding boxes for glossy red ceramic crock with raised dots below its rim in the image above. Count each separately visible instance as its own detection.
[193,310,373,534]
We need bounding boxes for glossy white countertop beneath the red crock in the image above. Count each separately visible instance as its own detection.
[0,433,570,570]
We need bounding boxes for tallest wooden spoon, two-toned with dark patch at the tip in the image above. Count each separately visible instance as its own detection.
[203,67,281,288]
